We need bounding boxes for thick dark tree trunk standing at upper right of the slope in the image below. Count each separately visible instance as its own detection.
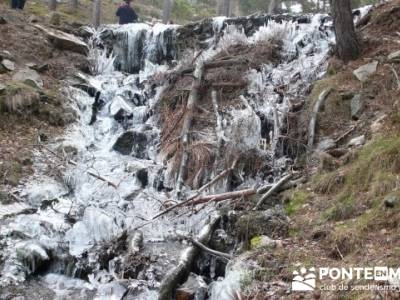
[330,0,361,62]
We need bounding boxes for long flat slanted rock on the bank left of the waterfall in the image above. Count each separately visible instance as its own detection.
[35,25,89,55]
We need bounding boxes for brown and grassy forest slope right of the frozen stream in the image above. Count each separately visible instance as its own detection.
[242,0,400,299]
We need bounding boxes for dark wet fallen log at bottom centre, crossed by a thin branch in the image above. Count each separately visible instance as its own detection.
[158,216,221,300]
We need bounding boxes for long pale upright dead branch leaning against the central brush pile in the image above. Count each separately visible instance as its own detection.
[176,62,204,199]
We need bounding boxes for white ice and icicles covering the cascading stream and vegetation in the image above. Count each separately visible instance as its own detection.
[0,15,333,299]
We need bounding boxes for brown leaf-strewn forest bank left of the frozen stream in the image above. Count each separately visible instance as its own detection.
[0,4,88,201]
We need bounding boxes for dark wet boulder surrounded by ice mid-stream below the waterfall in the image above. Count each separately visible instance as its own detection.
[113,131,147,158]
